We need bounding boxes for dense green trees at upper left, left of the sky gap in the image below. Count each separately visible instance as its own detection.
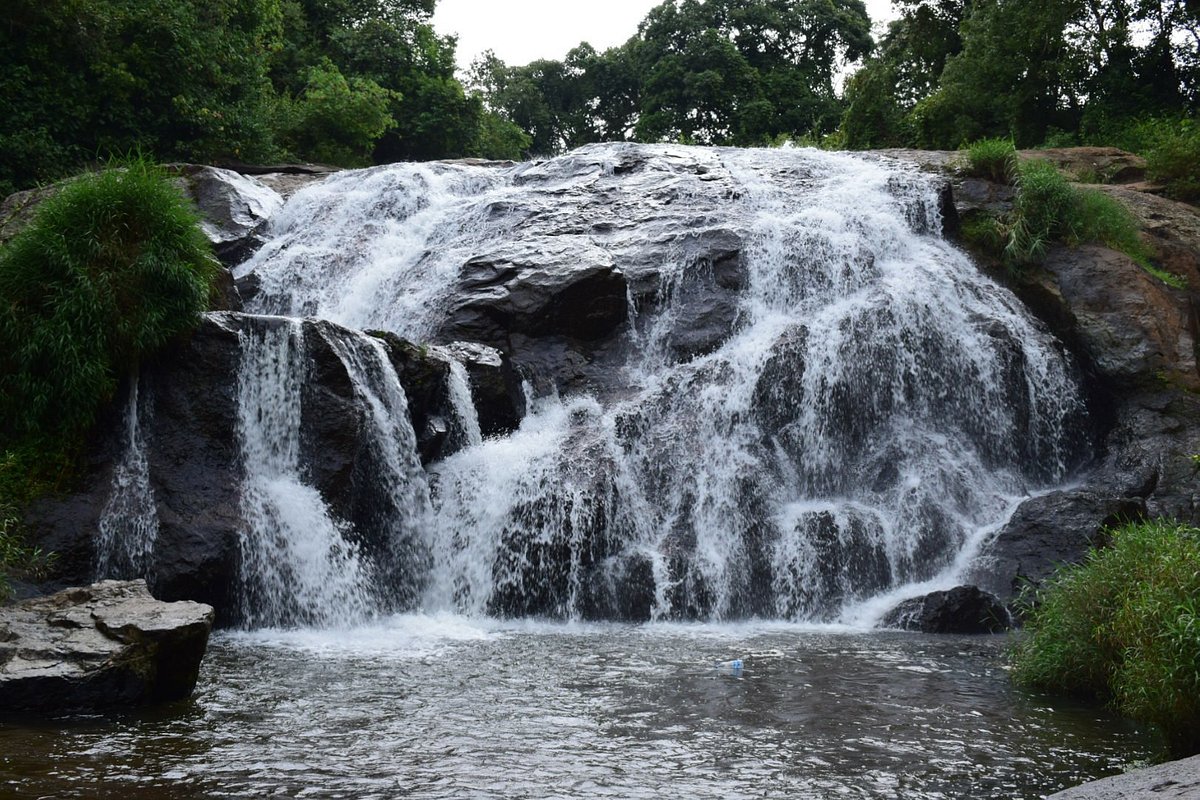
[0,0,524,192]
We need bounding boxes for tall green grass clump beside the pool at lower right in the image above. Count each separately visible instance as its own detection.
[1013,521,1200,757]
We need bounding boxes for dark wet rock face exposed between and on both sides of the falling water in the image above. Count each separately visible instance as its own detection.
[11,148,1200,621]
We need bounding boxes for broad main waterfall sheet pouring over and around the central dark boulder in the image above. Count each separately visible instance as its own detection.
[231,145,1082,620]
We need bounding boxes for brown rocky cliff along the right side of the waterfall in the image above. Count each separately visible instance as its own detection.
[894,148,1200,601]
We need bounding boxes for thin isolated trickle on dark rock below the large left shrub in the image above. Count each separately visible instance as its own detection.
[96,374,158,579]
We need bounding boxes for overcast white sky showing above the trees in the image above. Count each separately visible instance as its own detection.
[433,0,894,70]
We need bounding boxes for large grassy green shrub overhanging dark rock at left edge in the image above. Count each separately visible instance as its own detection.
[0,161,220,451]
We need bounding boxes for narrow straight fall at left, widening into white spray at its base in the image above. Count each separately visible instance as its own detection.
[238,320,376,627]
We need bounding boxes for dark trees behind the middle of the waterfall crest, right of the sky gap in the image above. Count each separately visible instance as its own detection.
[472,0,872,152]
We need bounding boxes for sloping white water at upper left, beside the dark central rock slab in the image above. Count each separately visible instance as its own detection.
[234,163,503,341]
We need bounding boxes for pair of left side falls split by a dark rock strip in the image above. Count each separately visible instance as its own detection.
[238,318,439,627]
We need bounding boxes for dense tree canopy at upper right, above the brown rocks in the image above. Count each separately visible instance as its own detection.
[844,0,1200,148]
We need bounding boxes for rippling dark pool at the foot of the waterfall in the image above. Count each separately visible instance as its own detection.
[0,616,1150,800]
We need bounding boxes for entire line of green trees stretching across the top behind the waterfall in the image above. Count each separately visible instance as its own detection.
[0,0,1200,192]
